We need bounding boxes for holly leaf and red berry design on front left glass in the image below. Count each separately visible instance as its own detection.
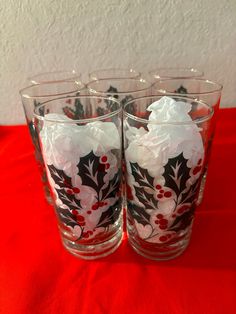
[47,151,121,240]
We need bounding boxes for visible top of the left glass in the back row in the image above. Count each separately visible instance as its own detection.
[28,70,81,84]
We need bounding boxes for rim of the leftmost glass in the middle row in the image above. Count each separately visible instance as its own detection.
[19,80,85,99]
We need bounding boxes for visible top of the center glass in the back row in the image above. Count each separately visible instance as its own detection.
[89,68,141,81]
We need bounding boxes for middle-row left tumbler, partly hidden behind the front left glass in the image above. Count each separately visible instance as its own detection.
[20,81,85,204]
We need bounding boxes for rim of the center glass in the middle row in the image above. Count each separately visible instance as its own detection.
[86,78,153,95]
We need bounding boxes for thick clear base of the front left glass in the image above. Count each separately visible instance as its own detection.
[62,229,123,260]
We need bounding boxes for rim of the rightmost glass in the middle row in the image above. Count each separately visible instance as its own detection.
[152,77,223,95]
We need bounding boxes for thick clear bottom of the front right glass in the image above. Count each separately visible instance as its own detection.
[128,228,191,261]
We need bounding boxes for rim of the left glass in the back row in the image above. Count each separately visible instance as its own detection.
[27,69,81,84]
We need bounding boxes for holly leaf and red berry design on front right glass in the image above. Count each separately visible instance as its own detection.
[127,153,202,243]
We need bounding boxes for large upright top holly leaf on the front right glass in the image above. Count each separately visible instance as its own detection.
[163,153,190,197]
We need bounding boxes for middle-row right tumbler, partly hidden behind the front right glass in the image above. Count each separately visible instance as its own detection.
[152,78,223,204]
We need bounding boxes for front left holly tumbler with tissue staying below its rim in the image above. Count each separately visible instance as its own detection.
[35,96,122,259]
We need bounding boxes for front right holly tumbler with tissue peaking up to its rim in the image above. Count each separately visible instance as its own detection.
[123,95,213,260]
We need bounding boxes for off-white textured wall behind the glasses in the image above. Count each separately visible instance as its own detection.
[0,0,236,124]
